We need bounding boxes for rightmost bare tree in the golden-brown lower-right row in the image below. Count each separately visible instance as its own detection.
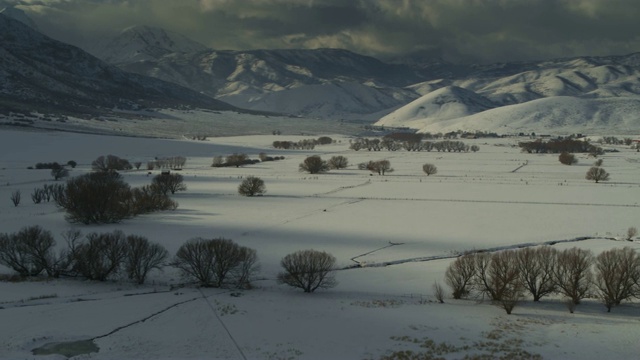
[594,247,640,312]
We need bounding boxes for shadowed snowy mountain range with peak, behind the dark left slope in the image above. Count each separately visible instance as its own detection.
[91,27,430,117]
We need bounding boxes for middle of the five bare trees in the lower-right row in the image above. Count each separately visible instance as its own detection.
[515,246,557,301]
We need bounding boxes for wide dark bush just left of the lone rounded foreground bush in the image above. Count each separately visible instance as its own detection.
[172,238,257,287]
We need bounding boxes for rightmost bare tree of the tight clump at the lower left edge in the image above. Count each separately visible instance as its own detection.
[124,235,169,284]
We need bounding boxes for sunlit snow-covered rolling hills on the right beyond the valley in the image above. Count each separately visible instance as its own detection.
[376,53,640,133]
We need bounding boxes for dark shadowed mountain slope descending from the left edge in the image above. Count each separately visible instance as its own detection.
[0,14,235,114]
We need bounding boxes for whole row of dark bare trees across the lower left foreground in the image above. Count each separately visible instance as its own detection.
[0,226,336,293]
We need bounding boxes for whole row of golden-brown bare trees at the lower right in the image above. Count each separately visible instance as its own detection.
[445,246,640,314]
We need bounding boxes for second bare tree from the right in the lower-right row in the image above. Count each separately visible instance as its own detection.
[554,247,593,305]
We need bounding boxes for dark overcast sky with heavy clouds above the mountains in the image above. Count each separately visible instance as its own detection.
[0,0,640,63]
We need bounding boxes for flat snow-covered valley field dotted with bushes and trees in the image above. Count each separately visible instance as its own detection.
[0,125,640,359]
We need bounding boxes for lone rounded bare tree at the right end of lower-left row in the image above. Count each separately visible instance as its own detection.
[278,250,337,293]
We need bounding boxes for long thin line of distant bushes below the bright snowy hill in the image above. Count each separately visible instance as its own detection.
[349,133,480,152]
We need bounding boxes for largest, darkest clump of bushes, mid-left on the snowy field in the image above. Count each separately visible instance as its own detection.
[53,171,180,224]
